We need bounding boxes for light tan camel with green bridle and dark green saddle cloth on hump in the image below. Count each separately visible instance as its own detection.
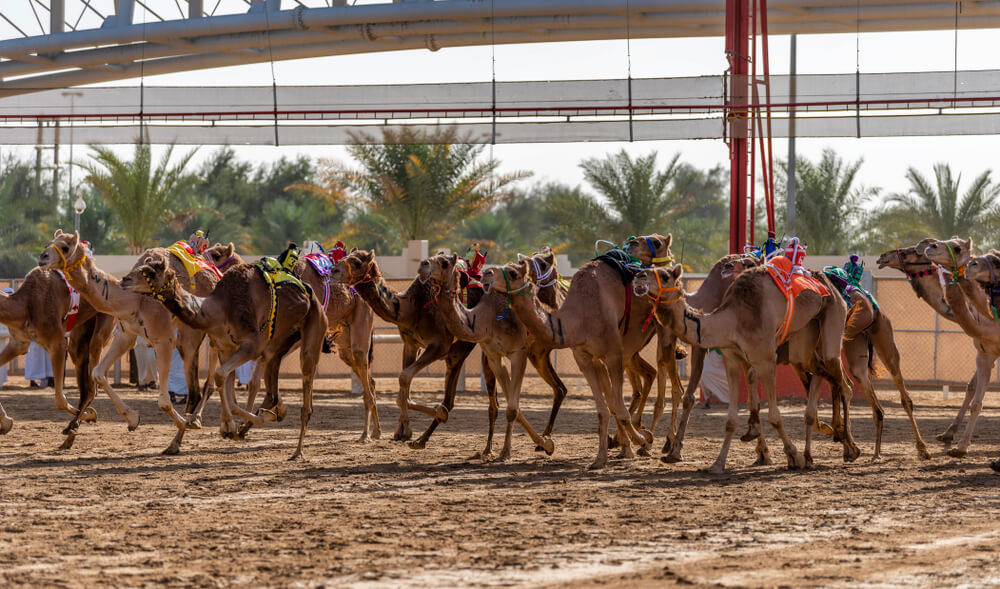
[483,260,653,468]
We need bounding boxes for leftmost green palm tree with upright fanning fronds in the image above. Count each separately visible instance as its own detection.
[82,143,197,254]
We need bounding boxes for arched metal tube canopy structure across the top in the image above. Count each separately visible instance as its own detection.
[0,0,1000,96]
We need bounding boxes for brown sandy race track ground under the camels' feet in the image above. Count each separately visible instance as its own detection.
[0,379,1000,587]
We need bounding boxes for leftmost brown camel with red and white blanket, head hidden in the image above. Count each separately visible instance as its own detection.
[0,268,114,438]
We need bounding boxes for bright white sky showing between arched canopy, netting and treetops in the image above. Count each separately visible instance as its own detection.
[1,0,1000,209]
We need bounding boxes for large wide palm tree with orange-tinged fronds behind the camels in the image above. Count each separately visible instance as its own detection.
[327,128,530,243]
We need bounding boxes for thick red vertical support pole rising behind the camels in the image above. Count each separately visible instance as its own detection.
[726,0,752,254]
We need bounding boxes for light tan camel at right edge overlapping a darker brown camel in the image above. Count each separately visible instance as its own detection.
[924,237,1000,458]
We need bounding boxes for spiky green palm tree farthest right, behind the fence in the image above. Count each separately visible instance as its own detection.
[886,163,1000,239]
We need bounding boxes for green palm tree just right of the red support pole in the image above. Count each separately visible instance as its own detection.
[775,149,878,255]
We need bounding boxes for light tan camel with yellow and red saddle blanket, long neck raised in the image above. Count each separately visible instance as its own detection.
[38,229,205,454]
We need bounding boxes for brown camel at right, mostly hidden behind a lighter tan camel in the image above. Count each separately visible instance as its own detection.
[878,238,986,444]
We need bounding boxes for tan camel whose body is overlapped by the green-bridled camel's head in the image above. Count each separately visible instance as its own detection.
[419,253,565,461]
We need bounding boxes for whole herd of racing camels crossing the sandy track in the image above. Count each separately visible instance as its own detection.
[0,231,1000,472]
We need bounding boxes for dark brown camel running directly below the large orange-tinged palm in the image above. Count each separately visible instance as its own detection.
[330,249,496,450]
